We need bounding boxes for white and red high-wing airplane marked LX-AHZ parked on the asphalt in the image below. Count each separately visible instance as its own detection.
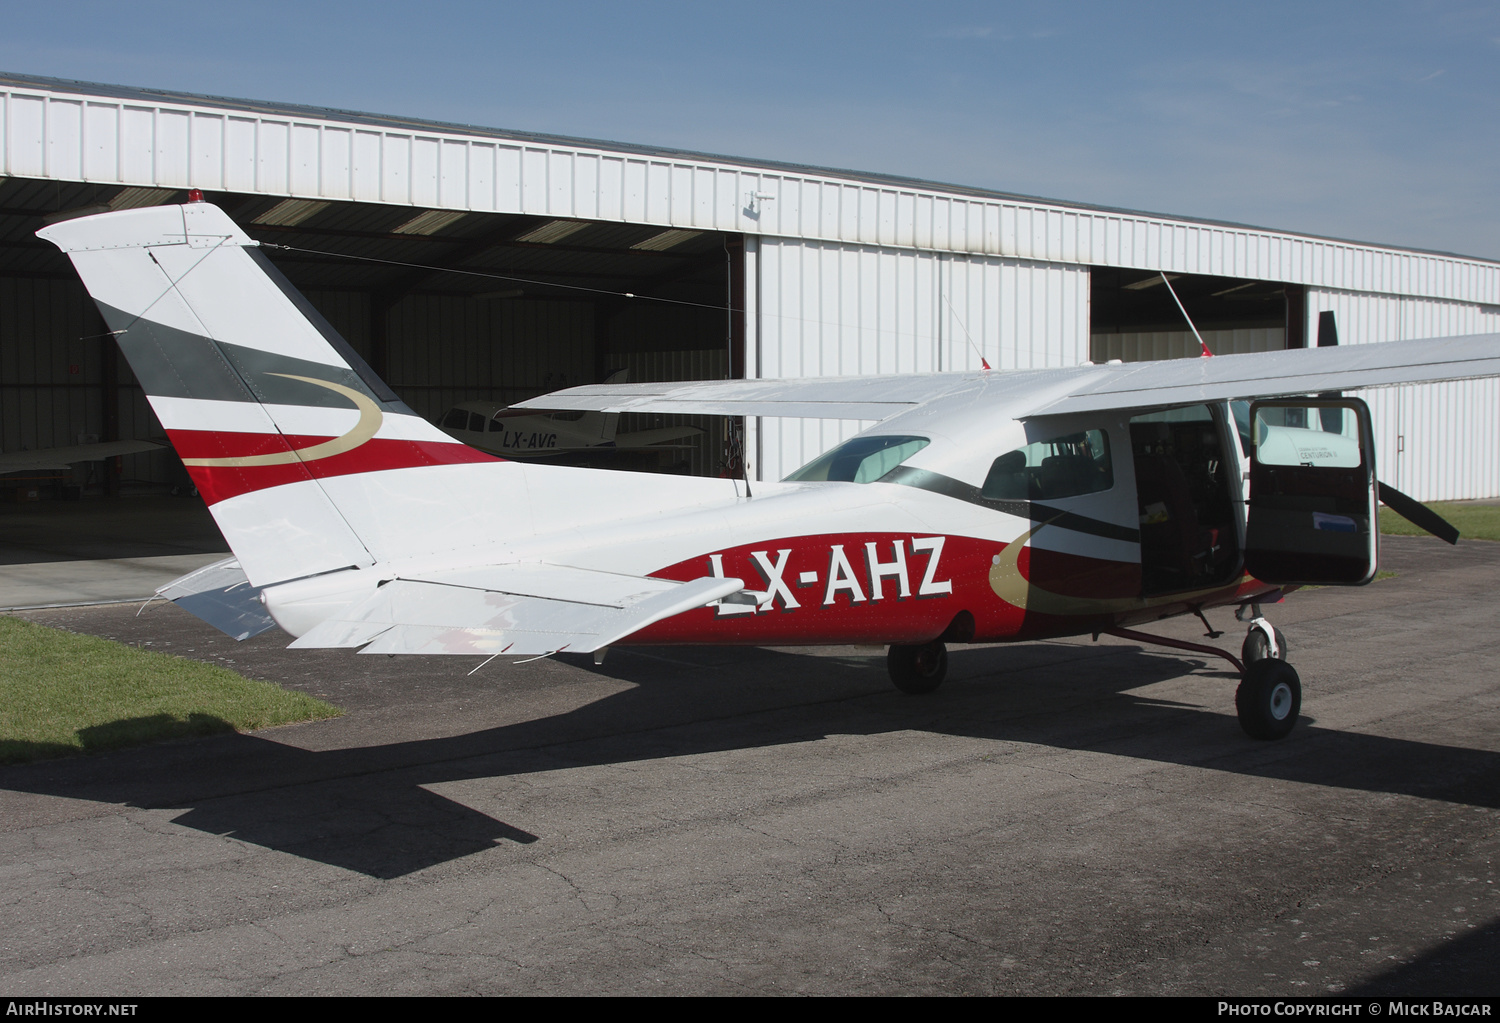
[38,197,1500,738]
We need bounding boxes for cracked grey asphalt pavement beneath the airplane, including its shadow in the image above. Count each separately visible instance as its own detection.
[0,537,1500,996]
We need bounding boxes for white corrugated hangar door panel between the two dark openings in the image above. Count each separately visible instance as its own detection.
[746,239,1089,480]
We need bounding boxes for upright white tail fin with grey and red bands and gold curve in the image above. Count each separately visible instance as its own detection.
[38,203,495,585]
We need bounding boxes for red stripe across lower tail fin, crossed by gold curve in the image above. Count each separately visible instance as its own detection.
[167,431,504,504]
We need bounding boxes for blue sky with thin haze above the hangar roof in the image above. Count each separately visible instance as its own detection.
[0,0,1500,258]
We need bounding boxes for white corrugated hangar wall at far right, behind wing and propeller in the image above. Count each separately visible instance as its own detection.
[1307,288,1500,501]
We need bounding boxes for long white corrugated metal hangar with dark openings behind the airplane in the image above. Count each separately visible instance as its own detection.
[0,75,1500,500]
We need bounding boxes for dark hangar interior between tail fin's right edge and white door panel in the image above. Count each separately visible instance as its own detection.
[247,197,744,474]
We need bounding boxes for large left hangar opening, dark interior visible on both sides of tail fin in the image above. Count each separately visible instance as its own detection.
[0,177,744,501]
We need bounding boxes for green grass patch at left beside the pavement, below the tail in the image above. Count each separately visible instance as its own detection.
[0,617,342,764]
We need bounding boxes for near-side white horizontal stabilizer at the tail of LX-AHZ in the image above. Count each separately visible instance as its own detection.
[291,564,744,656]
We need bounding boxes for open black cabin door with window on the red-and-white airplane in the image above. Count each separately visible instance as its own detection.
[1245,398,1380,587]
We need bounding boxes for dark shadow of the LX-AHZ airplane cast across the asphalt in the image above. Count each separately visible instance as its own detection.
[0,644,1500,878]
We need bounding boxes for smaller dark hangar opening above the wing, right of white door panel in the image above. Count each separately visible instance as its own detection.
[1089,267,1307,363]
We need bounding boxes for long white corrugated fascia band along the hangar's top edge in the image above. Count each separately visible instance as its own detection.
[0,80,1500,305]
